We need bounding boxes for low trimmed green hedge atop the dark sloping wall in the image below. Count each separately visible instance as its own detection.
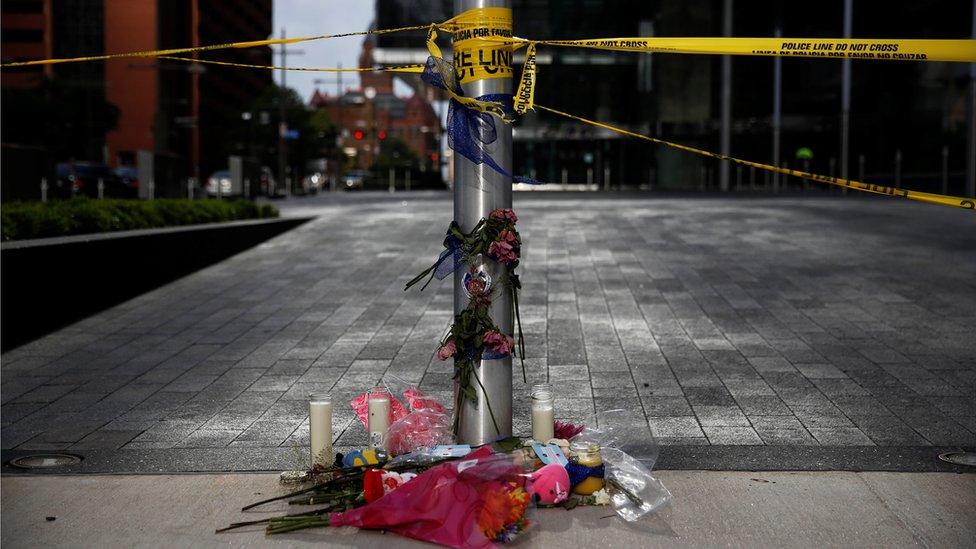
[0,198,278,241]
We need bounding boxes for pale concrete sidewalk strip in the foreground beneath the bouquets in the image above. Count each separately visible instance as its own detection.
[2,471,976,548]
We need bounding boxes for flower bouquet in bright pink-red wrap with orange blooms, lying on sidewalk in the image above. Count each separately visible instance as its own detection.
[329,447,533,548]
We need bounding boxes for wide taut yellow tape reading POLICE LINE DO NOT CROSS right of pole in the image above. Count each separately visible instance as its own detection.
[528,36,976,63]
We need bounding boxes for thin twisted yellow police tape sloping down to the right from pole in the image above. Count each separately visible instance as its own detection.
[535,104,976,210]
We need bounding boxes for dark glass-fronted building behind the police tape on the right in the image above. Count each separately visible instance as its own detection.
[374,0,973,194]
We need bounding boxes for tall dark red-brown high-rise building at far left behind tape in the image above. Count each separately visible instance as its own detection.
[0,0,273,178]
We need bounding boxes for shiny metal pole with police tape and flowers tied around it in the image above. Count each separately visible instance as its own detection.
[454,0,513,444]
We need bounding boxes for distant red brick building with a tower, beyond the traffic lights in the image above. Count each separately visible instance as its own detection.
[309,38,441,169]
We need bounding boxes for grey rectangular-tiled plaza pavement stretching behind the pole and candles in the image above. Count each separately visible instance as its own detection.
[0,194,976,469]
